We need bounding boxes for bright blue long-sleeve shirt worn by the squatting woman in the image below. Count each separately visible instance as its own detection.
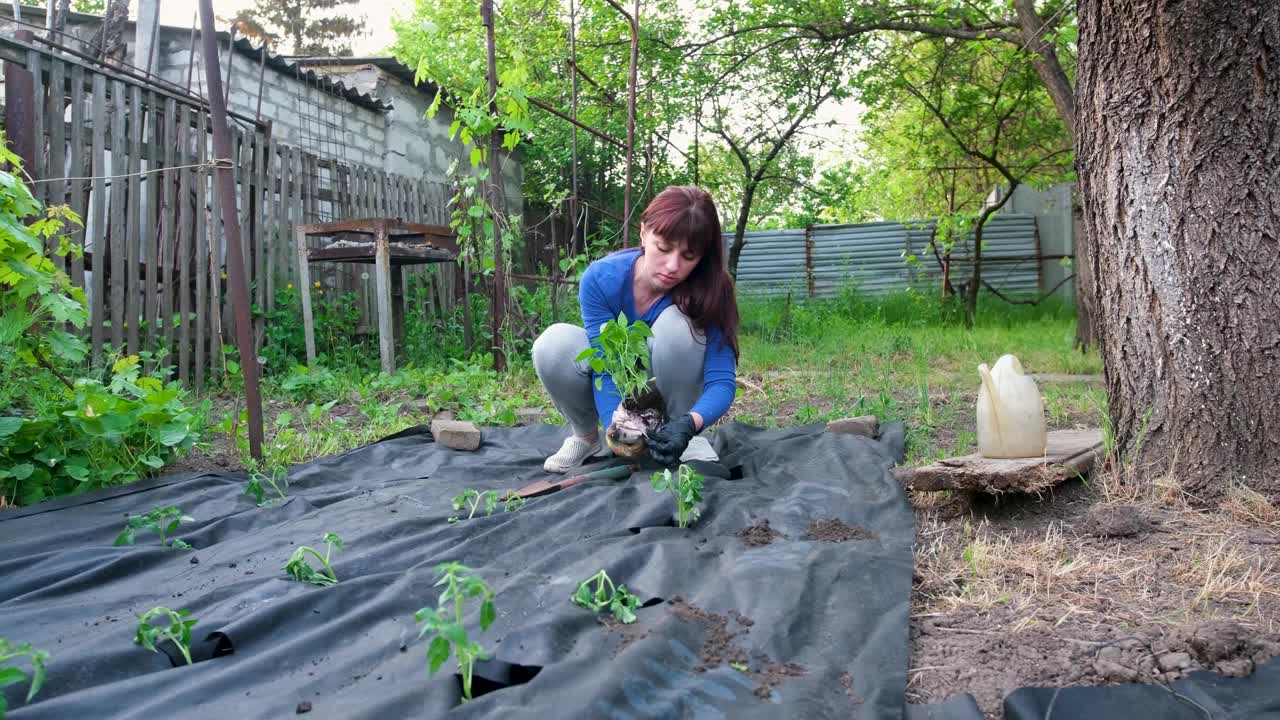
[579,250,737,428]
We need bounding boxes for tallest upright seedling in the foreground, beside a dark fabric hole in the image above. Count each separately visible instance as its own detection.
[413,562,497,702]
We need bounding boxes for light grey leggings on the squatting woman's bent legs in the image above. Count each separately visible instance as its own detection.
[534,305,707,437]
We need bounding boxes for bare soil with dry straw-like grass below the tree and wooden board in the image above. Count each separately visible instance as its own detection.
[908,478,1280,719]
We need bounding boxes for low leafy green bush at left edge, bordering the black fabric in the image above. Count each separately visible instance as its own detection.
[0,355,207,505]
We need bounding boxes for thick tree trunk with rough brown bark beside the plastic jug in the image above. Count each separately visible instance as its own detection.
[1075,0,1280,503]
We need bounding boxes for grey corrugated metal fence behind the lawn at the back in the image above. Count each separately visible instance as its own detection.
[726,214,1042,297]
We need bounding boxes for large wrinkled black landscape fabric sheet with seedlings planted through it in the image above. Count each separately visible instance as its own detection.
[0,424,913,720]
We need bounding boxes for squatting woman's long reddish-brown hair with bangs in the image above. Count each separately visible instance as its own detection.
[640,186,739,363]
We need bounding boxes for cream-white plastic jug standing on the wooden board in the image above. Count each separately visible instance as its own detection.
[978,355,1048,457]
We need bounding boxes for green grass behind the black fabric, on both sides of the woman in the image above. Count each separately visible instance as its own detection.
[175,283,1106,468]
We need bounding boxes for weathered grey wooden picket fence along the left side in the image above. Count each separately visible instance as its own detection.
[0,37,456,388]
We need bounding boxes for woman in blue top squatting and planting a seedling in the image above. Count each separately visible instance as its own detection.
[534,187,739,473]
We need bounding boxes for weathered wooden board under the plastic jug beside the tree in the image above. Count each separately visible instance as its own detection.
[895,428,1102,493]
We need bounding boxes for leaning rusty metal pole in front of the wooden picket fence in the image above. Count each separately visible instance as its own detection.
[200,0,262,460]
